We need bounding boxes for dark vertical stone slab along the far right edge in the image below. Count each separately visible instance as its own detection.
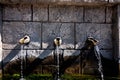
[113,5,120,74]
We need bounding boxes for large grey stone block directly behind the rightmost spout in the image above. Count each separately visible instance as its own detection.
[76,23,112,49]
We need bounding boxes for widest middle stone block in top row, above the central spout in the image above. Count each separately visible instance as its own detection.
[49,6,83,22]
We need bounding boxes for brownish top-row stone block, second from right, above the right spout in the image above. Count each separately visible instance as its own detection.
[84,7,105,23]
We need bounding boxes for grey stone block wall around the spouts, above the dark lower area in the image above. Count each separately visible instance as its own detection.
[1,0,118,77]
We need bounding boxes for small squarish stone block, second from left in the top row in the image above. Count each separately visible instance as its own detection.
[33,5,48,21]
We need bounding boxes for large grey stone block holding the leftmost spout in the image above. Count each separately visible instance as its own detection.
[3,22,41,49]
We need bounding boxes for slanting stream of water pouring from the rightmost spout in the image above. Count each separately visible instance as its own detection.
[94,45,104,80]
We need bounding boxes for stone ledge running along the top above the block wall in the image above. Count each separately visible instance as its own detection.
[0,0,117,5]
